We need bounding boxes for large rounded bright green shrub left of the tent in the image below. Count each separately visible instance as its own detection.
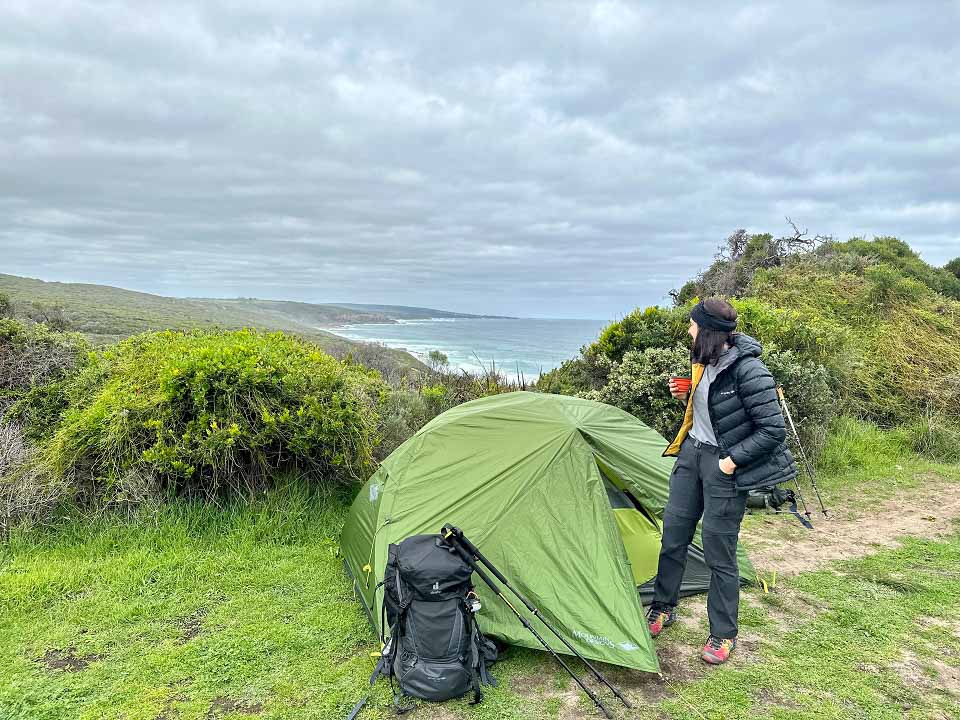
[43,330,387,501]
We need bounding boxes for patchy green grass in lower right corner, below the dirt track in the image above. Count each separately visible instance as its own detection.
[662,528,960,719]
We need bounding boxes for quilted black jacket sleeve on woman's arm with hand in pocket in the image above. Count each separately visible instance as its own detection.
[727,360,787,467]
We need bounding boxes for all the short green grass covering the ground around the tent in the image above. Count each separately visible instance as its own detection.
[0,448,960,720]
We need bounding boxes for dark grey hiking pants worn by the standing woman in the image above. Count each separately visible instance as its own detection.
[653,437,747,638]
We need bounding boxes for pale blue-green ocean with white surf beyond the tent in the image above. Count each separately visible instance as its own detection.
[325,318,610,380]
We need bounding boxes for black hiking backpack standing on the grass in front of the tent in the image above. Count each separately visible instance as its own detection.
[370,535,497,712]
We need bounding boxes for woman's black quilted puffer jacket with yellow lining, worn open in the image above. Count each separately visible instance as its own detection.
[664,333,797,490]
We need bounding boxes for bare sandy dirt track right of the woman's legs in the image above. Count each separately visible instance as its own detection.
[742,481,960,575]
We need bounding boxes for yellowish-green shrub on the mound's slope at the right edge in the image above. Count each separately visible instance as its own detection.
[754,264,960,427]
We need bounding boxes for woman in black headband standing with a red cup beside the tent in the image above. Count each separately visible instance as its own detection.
[647,298,797,664]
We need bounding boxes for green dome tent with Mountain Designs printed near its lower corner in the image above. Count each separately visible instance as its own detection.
[342,392,752,672]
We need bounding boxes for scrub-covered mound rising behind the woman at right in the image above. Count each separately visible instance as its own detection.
[538,231,960,464]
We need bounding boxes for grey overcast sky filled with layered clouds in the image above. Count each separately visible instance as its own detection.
[0,0,960,319]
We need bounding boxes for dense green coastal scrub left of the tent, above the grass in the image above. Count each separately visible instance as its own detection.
[0,319,512,532]
